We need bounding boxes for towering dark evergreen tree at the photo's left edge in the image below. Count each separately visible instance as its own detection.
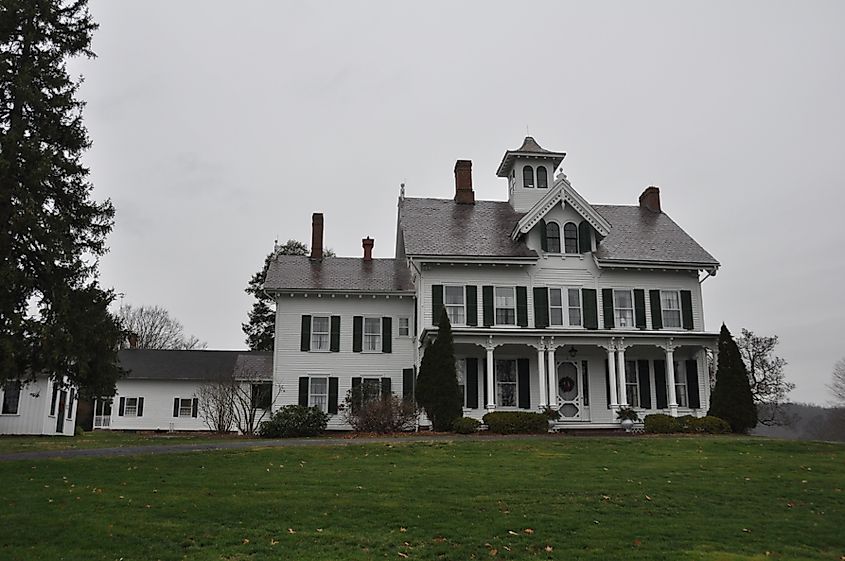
[0,0,122,394]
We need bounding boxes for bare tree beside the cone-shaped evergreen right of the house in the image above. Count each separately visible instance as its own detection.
[736,329,795,425]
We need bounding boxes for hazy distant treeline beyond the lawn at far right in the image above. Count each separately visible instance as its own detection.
[752,403,845,442]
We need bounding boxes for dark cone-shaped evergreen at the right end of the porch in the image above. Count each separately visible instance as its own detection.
[707,324,757,433]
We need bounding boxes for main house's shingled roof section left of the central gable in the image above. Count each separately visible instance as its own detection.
[399,198,537,258]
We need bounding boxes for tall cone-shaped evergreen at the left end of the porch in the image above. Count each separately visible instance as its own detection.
[416,310,462,431]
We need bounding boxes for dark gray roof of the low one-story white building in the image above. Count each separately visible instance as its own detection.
[117,349,273,381]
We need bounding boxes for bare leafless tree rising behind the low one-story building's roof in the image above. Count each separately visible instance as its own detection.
[117,304,206,350]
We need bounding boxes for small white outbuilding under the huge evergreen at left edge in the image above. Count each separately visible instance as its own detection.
[0,376,79,436]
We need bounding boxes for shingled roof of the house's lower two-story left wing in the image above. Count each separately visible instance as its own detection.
[264,255,414,292]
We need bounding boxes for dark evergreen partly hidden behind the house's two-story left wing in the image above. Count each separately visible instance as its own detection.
[241,240,334,351]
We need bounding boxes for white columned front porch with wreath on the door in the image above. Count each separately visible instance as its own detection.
[446,330,715,429]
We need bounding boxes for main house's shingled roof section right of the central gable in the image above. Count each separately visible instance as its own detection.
[592,205,719,266]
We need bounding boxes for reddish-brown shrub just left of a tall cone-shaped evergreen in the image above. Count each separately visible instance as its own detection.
[344,388,417,434]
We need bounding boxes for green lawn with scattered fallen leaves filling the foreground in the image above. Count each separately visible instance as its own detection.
[0,437,845,561]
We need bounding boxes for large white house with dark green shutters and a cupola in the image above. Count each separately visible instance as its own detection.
[265,137,719,428]
